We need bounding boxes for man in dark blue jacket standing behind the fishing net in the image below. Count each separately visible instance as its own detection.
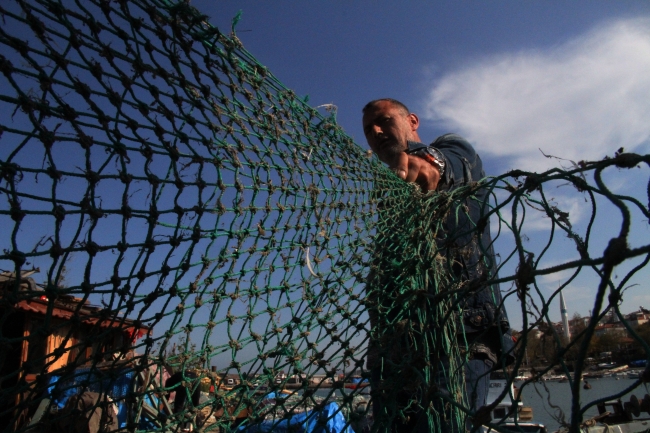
[363,98,511,432]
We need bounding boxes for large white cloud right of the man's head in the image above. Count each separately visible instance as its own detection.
[425,19,650,171]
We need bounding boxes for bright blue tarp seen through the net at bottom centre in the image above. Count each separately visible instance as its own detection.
[240,393,354,433]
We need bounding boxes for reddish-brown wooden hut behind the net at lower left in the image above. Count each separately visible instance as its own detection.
[0,269,150,425]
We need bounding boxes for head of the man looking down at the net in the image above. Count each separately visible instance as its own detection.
[363,101,419,165]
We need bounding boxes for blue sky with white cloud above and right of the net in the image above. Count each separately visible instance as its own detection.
[186,0,650,326]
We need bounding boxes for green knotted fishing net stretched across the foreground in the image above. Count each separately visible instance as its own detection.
[0,0,650,432]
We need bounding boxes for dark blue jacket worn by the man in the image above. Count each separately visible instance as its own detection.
[408,134,512,361]
